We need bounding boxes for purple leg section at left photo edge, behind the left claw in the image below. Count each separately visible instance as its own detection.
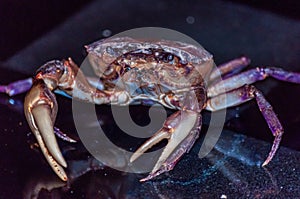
[0,77,32,96]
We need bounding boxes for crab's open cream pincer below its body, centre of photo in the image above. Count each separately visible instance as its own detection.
[130,111,201,182]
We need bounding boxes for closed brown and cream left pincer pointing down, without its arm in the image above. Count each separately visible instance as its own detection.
[24,79,67,181]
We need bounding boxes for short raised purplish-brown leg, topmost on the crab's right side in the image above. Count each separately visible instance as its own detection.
[209,56,250,81]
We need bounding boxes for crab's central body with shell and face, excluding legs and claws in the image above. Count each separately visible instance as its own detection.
[86,37,214,111]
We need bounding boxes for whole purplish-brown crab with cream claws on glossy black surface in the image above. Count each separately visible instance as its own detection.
[0,37,300,181]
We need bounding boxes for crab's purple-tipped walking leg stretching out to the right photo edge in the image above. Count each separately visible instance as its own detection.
[208,67,300,97]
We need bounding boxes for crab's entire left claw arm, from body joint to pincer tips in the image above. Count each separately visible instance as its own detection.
[24,58,116,181]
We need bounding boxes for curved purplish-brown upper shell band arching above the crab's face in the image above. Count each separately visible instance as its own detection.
[86,37,214,78]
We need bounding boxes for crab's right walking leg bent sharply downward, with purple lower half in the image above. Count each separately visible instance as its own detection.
[206,85,284,166]
